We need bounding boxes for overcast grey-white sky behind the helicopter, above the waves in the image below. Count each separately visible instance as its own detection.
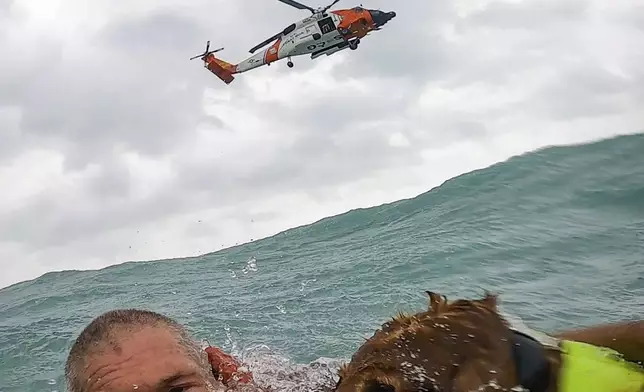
[0,0,644,287]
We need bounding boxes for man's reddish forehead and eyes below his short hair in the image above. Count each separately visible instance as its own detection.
[84,327,224,392]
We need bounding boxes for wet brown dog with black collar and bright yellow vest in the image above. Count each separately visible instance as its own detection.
[335,291,644,392]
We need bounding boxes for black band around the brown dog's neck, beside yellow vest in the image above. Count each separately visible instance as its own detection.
[510,331,550,392]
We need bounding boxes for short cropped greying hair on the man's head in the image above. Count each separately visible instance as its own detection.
[65,309,205,392]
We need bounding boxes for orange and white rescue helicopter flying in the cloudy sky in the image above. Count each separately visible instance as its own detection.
[190,0,396,84]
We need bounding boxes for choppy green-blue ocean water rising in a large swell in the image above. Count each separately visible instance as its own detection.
[0,135,644,392]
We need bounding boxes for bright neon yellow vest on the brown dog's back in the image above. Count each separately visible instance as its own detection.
[559,340,644,392]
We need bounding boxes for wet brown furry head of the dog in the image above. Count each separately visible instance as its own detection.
[335,291,517,392]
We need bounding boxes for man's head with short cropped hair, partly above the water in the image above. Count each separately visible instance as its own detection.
[65,309,219,392]
